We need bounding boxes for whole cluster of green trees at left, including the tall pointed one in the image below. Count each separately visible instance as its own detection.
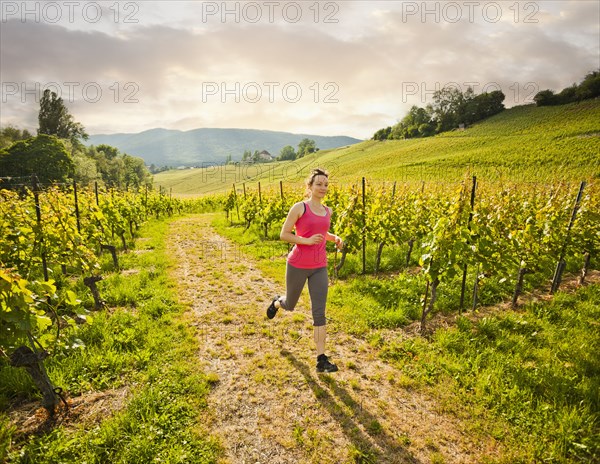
[0,89,152,189]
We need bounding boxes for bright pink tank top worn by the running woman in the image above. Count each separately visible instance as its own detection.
[287,202,331,269]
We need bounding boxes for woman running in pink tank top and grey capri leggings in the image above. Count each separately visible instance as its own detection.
[267,169,343,372]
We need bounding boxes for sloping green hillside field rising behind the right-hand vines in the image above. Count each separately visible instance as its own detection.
[154,100,600,196]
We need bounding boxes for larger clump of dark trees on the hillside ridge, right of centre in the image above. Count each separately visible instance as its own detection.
[373,87,505,140]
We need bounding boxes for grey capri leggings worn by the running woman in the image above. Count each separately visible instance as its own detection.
[279,263,329,327]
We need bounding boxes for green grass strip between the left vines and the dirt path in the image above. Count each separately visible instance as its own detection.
[0,221,220,464]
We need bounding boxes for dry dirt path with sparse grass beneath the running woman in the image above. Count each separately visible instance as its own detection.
[168,216,498,464]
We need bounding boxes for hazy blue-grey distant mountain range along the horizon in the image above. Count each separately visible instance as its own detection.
[86,129,361,167]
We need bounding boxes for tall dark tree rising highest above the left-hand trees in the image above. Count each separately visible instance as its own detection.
[38,89,88,140]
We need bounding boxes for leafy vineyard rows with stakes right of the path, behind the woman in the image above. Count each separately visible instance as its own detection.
[225,177,600,334]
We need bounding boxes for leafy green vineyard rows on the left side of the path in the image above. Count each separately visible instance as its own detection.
[0,183,218,412]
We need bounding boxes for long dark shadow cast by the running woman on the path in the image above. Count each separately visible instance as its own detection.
[281,350,421,464]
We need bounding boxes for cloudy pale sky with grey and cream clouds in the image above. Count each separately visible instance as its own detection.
[0,0,600,138]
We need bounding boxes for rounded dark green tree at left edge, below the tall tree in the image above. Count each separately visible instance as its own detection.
[0,134,74,183]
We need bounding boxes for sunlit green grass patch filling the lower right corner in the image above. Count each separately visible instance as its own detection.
[379,284,600,463]
